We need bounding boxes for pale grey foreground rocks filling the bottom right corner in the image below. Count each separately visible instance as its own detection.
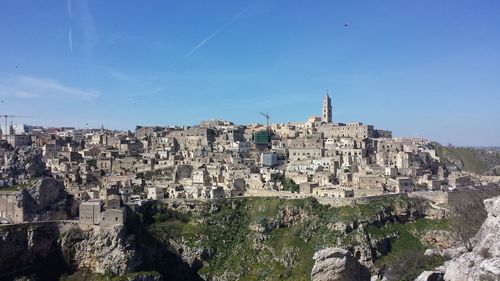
[436,197,500,281]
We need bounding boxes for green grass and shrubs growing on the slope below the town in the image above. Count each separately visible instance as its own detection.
[133,197,449,280]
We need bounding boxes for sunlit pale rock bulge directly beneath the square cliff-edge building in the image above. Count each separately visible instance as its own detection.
[61,226,140,275]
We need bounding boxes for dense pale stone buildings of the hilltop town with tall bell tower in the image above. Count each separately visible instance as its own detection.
[0,94,484,226]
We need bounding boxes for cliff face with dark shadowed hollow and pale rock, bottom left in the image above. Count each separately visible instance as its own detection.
[0,223,140,280]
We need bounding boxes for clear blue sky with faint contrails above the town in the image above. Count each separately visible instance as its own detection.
[0,0,500,145]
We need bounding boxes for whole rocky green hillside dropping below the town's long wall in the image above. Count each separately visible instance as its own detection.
[124,197,449,280]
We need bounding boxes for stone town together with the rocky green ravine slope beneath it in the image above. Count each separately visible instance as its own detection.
[0,94,500,281]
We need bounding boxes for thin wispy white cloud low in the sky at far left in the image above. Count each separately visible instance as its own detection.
[0,75,100,100]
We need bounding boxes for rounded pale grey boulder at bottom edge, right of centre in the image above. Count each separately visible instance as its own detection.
[311,248,370,281]
